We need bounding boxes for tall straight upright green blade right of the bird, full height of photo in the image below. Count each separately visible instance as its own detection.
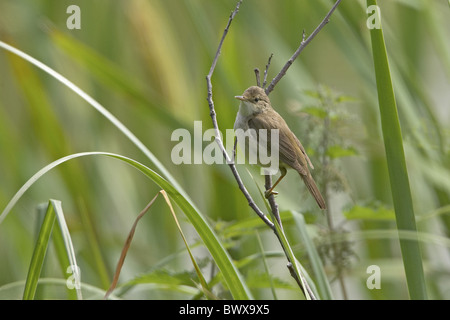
[367,0,427,299]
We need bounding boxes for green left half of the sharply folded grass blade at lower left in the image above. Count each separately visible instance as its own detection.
[23,201,56,300]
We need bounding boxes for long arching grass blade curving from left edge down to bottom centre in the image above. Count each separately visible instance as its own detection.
[0,152,252,300]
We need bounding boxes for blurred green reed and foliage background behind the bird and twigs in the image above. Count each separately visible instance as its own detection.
[0,0,450,299]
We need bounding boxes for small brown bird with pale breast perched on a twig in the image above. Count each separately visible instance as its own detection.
[234,86,326,209]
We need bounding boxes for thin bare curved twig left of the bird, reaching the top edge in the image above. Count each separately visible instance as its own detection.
[206,0,275,230]
